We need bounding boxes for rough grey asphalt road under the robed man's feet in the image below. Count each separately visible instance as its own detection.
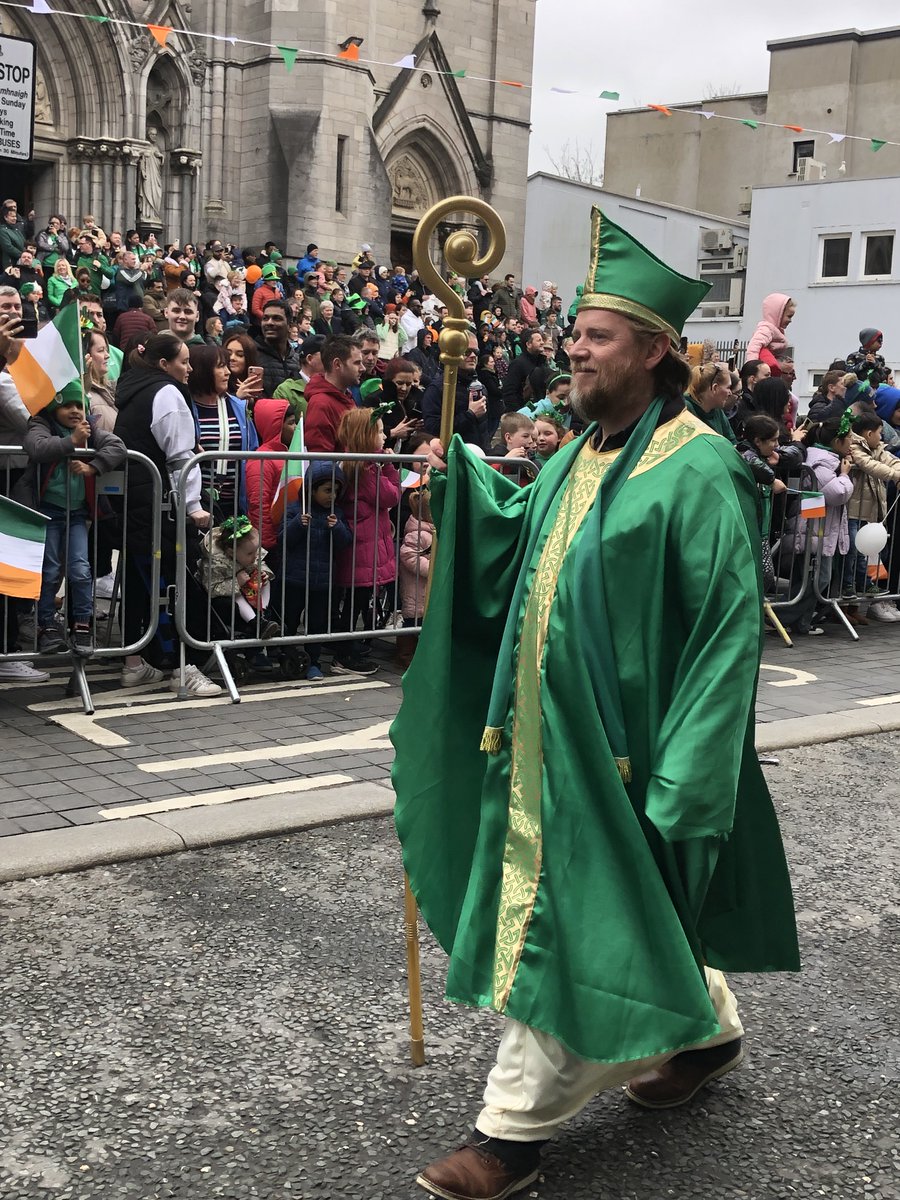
[0,729,900,1200]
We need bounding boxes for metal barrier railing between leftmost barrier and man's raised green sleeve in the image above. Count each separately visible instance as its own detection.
[175,450,536,703]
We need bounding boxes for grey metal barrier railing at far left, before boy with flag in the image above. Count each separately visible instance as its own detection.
[0,446,165,714]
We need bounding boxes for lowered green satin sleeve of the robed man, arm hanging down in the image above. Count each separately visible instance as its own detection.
[646,440,762,842]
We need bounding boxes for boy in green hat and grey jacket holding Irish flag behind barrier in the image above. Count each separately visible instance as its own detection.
[13,380,125,655]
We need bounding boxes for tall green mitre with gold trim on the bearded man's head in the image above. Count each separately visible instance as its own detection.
[578,208,709,349]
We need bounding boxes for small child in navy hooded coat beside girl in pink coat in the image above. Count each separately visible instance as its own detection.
[278,462,353,680]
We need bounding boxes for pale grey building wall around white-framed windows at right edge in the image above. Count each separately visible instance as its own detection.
[742,179,900,396]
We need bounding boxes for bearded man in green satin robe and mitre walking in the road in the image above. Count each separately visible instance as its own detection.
[392,209,799,1200]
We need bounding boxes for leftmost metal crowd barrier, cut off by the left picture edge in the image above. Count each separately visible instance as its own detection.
[0,446,165,714]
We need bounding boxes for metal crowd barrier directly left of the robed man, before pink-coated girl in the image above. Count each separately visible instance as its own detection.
[174,450,536,703]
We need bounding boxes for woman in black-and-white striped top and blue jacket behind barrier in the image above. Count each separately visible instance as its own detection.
[190,346,259,523]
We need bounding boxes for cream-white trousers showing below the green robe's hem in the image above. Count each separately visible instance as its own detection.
[476,968,744,1141]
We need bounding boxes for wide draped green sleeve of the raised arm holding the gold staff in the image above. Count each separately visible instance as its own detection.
[391,437,532,953]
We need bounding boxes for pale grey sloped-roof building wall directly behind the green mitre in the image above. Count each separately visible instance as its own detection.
[522,173,749,342]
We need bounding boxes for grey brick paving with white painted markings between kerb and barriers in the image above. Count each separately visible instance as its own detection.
[0,625,900,839]
